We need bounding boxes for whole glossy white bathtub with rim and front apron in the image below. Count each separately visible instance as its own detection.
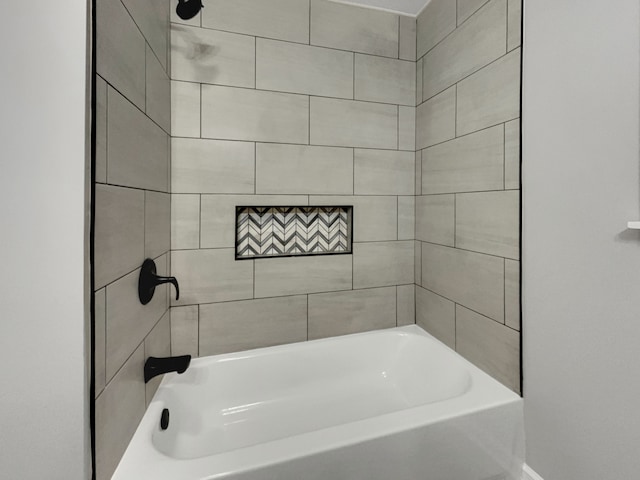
[113,325,524,480]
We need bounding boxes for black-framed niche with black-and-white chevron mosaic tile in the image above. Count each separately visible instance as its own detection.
[236,206,353,260]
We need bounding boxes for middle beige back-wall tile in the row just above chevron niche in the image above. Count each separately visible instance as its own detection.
[256,143,353,195]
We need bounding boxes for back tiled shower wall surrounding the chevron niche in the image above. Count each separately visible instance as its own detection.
[171,0,416,355]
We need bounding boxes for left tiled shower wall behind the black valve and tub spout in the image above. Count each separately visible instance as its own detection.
[94,0,171,480]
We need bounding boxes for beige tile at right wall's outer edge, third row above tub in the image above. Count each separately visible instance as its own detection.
[456,190,520,259]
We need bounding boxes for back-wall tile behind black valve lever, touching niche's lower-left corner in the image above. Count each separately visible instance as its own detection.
[171,248,253,306]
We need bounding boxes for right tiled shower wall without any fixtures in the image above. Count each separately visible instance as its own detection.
[416,0,521,392]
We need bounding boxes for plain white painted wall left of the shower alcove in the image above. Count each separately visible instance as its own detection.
[0,0,90,480]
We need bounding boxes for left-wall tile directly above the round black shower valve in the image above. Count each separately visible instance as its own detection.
[144,192,171,258]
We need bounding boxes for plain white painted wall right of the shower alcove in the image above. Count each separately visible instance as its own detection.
[523,0,640,480]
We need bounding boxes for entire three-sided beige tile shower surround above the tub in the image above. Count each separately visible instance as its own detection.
[95,0,520,479]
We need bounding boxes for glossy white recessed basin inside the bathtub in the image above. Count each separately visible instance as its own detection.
[153,326,471,459]
